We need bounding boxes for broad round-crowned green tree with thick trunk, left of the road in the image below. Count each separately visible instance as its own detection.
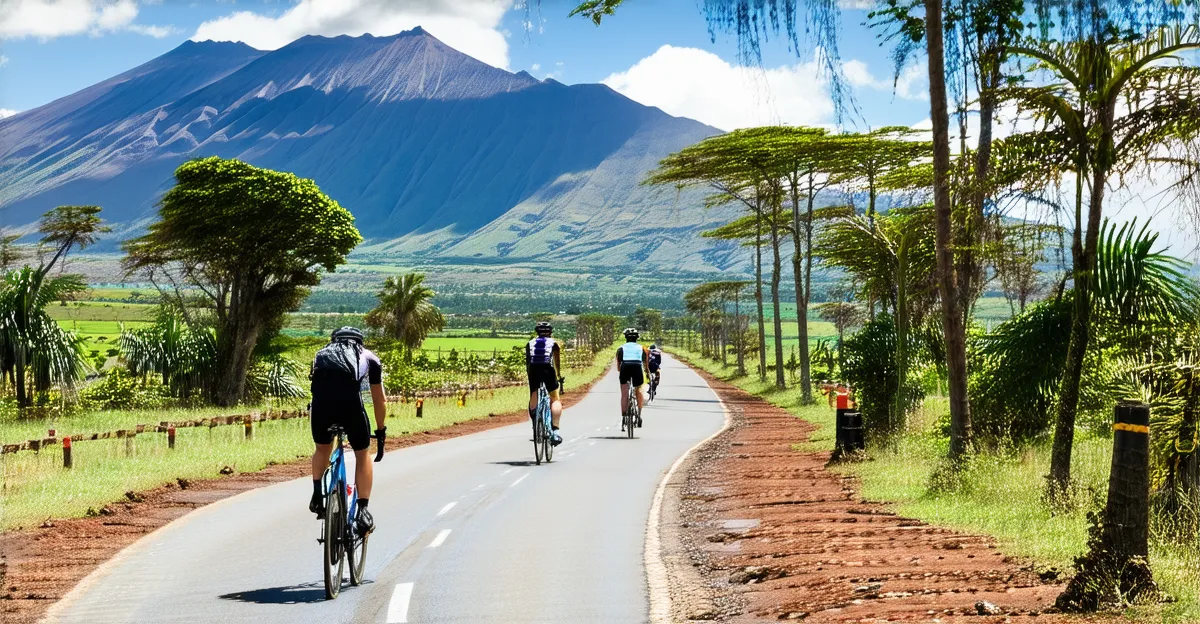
[124,156,362,406]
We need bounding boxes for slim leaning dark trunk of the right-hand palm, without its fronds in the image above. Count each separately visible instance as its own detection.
[1050,136,1111,496]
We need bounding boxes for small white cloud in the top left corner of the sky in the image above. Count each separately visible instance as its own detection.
[0,0,169,40]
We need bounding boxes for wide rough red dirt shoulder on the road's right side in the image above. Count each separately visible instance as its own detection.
[680,373,1118,623]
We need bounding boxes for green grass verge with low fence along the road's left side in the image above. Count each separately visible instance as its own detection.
[0,349,610,530]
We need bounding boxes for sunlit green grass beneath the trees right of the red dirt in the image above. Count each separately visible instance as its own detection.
[677,350,1200,623]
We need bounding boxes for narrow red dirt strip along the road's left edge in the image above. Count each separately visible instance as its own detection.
[0,364,602,624]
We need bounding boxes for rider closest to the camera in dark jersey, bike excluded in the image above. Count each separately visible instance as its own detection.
[308,328,388,534]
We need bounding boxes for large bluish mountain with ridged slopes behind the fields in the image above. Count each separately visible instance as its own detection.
[0,28,745,271]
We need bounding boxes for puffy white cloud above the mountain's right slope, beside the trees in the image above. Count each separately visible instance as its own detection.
[602,46,834,130]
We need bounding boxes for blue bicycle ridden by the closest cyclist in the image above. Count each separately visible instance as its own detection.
[317,425,369,600]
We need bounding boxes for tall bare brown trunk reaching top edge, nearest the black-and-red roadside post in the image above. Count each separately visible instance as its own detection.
[925,0,971,460]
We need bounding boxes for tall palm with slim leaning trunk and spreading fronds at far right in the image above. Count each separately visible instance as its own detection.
[1004,26,1200,492]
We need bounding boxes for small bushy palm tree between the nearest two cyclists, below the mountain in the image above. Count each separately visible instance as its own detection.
[366,272,445,360]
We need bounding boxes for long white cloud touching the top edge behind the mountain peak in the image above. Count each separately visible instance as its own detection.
[192,0,512,68]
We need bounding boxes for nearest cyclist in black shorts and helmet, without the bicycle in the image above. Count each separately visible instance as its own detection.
[308,328,388,535]
